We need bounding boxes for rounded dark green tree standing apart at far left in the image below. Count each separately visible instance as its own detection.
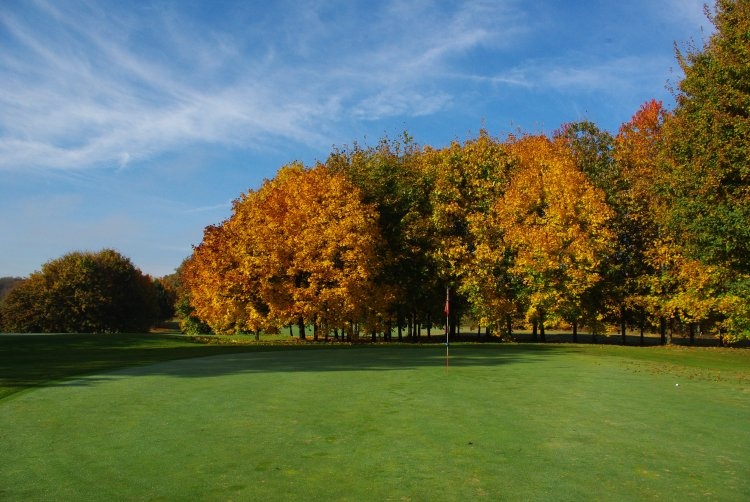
[0,249,158,333]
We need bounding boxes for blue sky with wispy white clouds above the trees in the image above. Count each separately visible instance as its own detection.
[0,0,712,277]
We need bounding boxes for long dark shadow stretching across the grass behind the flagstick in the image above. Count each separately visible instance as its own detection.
[0,335,576,398]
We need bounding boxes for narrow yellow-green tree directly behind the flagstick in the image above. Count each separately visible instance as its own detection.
[422,130,515,336]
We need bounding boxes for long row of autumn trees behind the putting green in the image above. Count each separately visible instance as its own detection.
[0,0,750,342]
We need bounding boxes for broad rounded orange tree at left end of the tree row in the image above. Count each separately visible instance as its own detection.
[183,164,388,338]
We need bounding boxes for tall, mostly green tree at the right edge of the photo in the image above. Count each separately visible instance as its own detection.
[663,0,750,337]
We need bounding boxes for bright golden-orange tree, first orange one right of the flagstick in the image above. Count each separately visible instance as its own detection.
[494,136,613,335]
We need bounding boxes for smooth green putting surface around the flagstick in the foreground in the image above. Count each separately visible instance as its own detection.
[0,344,750,500]
